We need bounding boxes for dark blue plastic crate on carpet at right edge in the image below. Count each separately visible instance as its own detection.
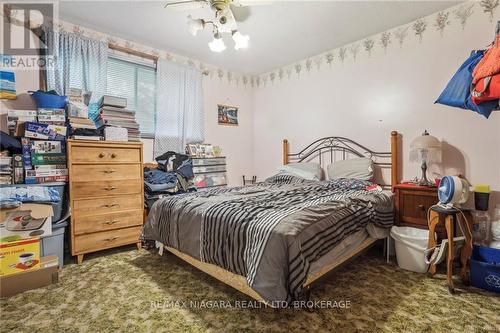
[470,245,500,293]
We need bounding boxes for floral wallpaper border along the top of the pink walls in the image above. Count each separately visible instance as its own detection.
[54,0,500,88]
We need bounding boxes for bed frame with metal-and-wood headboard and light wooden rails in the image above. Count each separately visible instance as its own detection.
[156,131,399,306]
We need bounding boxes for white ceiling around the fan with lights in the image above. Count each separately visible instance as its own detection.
[59,0,461,74]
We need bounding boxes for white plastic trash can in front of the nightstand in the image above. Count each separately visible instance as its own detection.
[391,226,429,273]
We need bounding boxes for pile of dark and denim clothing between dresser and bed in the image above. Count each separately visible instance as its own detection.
[144,151,196,208]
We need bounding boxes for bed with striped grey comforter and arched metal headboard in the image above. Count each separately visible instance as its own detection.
[142,131,398,306]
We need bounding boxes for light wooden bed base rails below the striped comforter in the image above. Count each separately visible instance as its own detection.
[164,238,377,307]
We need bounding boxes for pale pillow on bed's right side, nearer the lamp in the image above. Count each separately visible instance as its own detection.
[327,157,373,181]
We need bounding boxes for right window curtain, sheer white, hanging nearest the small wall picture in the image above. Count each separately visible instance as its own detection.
[154,59,204,157]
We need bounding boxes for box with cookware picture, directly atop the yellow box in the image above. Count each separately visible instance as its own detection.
[0,203,54,243]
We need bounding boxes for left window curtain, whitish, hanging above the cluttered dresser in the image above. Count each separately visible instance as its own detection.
[44,27,108,102]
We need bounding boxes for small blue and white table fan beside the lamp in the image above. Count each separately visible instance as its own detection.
[438,176,470,208]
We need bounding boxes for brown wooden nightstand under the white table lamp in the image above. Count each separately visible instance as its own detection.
[394,184,446,238]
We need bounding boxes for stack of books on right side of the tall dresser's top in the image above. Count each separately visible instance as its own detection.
[96,95,141,141]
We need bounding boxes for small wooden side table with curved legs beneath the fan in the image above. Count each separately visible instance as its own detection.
[428,206,473,293]
